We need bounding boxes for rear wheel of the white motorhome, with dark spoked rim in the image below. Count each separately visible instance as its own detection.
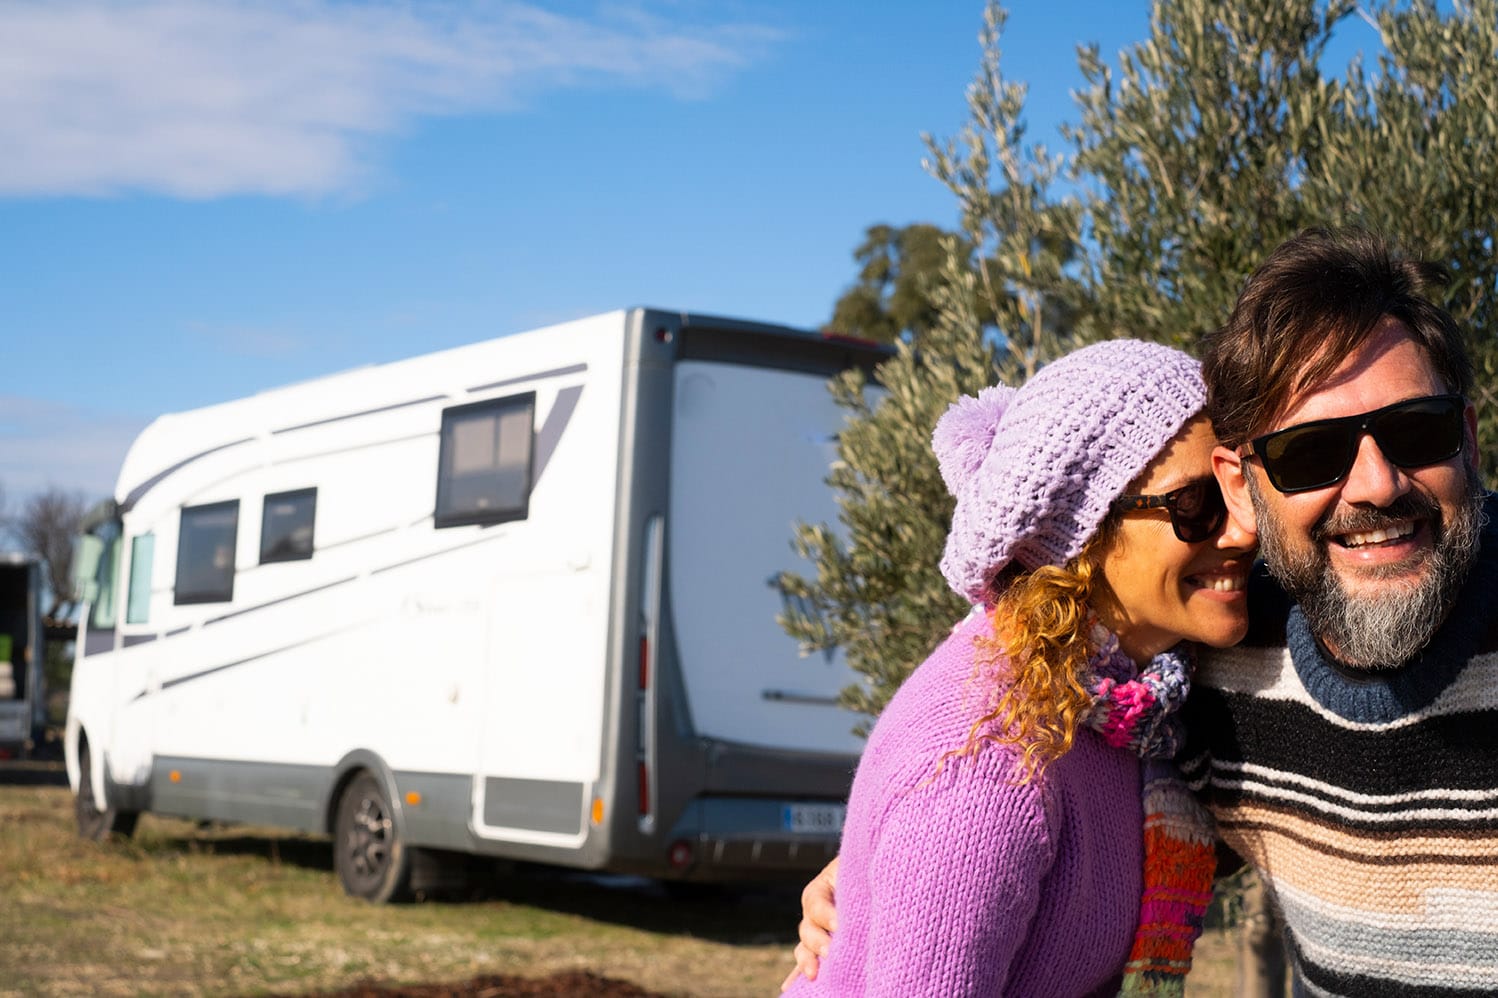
[333,772,410,904]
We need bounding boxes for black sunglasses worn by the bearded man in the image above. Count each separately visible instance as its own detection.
[1248,396,1467,493]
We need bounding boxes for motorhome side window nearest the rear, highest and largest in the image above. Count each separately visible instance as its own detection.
[434,391,536,527]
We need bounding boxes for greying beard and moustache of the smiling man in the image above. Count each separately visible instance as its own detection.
[1245,466,1486,670]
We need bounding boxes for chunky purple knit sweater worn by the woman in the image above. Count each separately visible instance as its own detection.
[791,614,1143,998]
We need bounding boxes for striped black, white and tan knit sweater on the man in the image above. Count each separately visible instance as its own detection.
[1182,500,1498,998]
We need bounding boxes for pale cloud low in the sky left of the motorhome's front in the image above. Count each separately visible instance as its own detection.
[0,396,150,494]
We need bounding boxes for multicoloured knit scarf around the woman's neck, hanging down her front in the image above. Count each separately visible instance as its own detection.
[1085,625,1216,998]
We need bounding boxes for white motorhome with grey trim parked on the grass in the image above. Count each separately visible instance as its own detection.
[66,309,885,901]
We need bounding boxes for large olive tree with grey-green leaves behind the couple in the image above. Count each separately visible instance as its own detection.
[780,0,1498,715]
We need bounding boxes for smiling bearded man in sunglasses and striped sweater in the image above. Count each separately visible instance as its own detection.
[797,229,1498,995]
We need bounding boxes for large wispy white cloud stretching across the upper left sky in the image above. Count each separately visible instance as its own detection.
[0,0,777,198]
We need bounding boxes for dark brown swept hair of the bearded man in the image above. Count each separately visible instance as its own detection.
[1201,228,1473,447]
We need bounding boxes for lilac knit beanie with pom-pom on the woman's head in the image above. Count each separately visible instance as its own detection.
[932,340,1206,602]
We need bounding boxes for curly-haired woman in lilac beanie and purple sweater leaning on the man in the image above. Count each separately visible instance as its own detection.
[789,340,1252,998]
